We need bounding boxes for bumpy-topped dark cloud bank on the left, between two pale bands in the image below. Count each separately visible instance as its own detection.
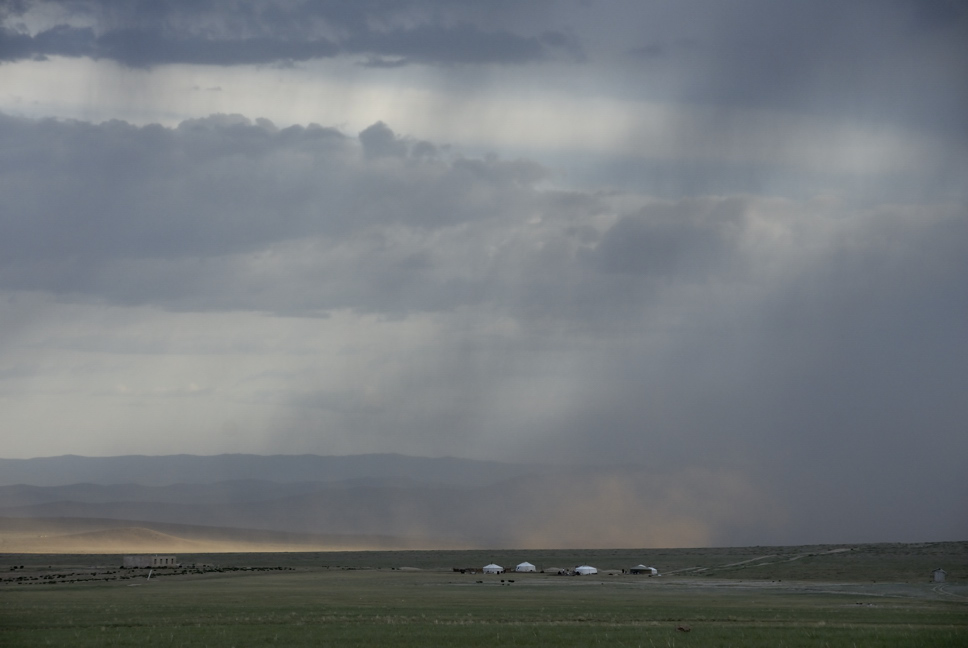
[0,115,544,310]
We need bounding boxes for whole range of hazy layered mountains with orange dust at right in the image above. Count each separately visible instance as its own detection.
[0,454,816,548]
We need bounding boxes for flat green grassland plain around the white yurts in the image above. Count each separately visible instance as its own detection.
[0,543,968,647]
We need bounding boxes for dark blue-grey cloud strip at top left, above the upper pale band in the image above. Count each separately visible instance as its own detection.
[0,2,568,68]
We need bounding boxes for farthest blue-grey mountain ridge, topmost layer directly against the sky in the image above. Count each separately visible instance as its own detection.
[0,454,547,486]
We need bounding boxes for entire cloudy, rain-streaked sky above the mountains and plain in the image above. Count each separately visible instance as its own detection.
[0,0,968,541]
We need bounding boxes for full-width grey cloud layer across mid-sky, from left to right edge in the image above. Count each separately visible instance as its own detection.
[0,115,966,318]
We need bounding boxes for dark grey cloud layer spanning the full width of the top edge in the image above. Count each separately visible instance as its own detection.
[0,0,968,128]
